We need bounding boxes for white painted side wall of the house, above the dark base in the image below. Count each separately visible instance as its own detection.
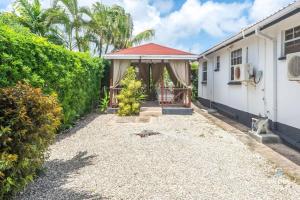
[198,13,300,133]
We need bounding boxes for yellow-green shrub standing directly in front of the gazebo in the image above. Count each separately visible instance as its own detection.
[117,67,145,116]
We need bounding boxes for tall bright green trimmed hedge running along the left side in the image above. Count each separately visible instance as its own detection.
[0,24,104,125]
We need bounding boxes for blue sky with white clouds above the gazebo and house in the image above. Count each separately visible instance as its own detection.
[0,0,294,53]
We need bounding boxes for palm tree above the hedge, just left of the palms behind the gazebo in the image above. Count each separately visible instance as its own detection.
[53,0,83,51]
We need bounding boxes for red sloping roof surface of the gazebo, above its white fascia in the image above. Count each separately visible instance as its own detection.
[110,43,194,55]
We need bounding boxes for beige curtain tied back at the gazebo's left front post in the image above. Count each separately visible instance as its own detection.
[112,60,131,87]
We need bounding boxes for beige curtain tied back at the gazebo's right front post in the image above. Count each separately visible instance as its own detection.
[169,60,189,87]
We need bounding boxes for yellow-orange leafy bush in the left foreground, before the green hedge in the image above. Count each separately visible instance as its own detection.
[0,83,61,199]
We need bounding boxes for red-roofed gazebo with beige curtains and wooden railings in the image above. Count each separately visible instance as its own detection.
[104,43,198,113]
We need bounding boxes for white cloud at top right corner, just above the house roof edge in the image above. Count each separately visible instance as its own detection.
[249,0,295,21]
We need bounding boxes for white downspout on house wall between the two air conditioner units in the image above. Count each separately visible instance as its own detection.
[255,28,278,129]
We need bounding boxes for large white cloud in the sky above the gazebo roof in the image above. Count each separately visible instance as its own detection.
[155,0,250,50]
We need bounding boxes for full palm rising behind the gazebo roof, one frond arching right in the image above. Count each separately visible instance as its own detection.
[83,2,155,57]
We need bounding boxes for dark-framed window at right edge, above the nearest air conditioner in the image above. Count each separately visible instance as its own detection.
[284,26,300,55]
